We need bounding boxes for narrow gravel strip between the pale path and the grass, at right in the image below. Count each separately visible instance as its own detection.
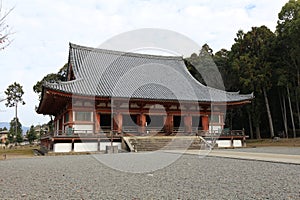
[221,147,300,155]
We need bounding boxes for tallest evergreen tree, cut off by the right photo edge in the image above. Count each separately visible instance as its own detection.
[276,0,300,137]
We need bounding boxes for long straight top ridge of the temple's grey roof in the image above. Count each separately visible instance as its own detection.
[69,42,183,60]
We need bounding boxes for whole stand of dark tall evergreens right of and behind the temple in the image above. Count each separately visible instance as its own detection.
[186,0,300,139]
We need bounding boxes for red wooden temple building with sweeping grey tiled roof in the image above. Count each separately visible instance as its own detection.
[37,44,253,152]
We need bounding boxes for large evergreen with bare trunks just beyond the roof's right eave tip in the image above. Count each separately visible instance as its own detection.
[230,26,275,138]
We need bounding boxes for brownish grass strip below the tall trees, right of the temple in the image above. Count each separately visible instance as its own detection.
[246,138,300,147]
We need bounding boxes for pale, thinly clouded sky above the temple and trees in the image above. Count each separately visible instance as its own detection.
[0,0,287,126]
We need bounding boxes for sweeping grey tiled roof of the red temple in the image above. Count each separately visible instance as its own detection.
[44,43,253,102]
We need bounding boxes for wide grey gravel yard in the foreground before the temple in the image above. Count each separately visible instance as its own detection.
[0,153,300,199]
